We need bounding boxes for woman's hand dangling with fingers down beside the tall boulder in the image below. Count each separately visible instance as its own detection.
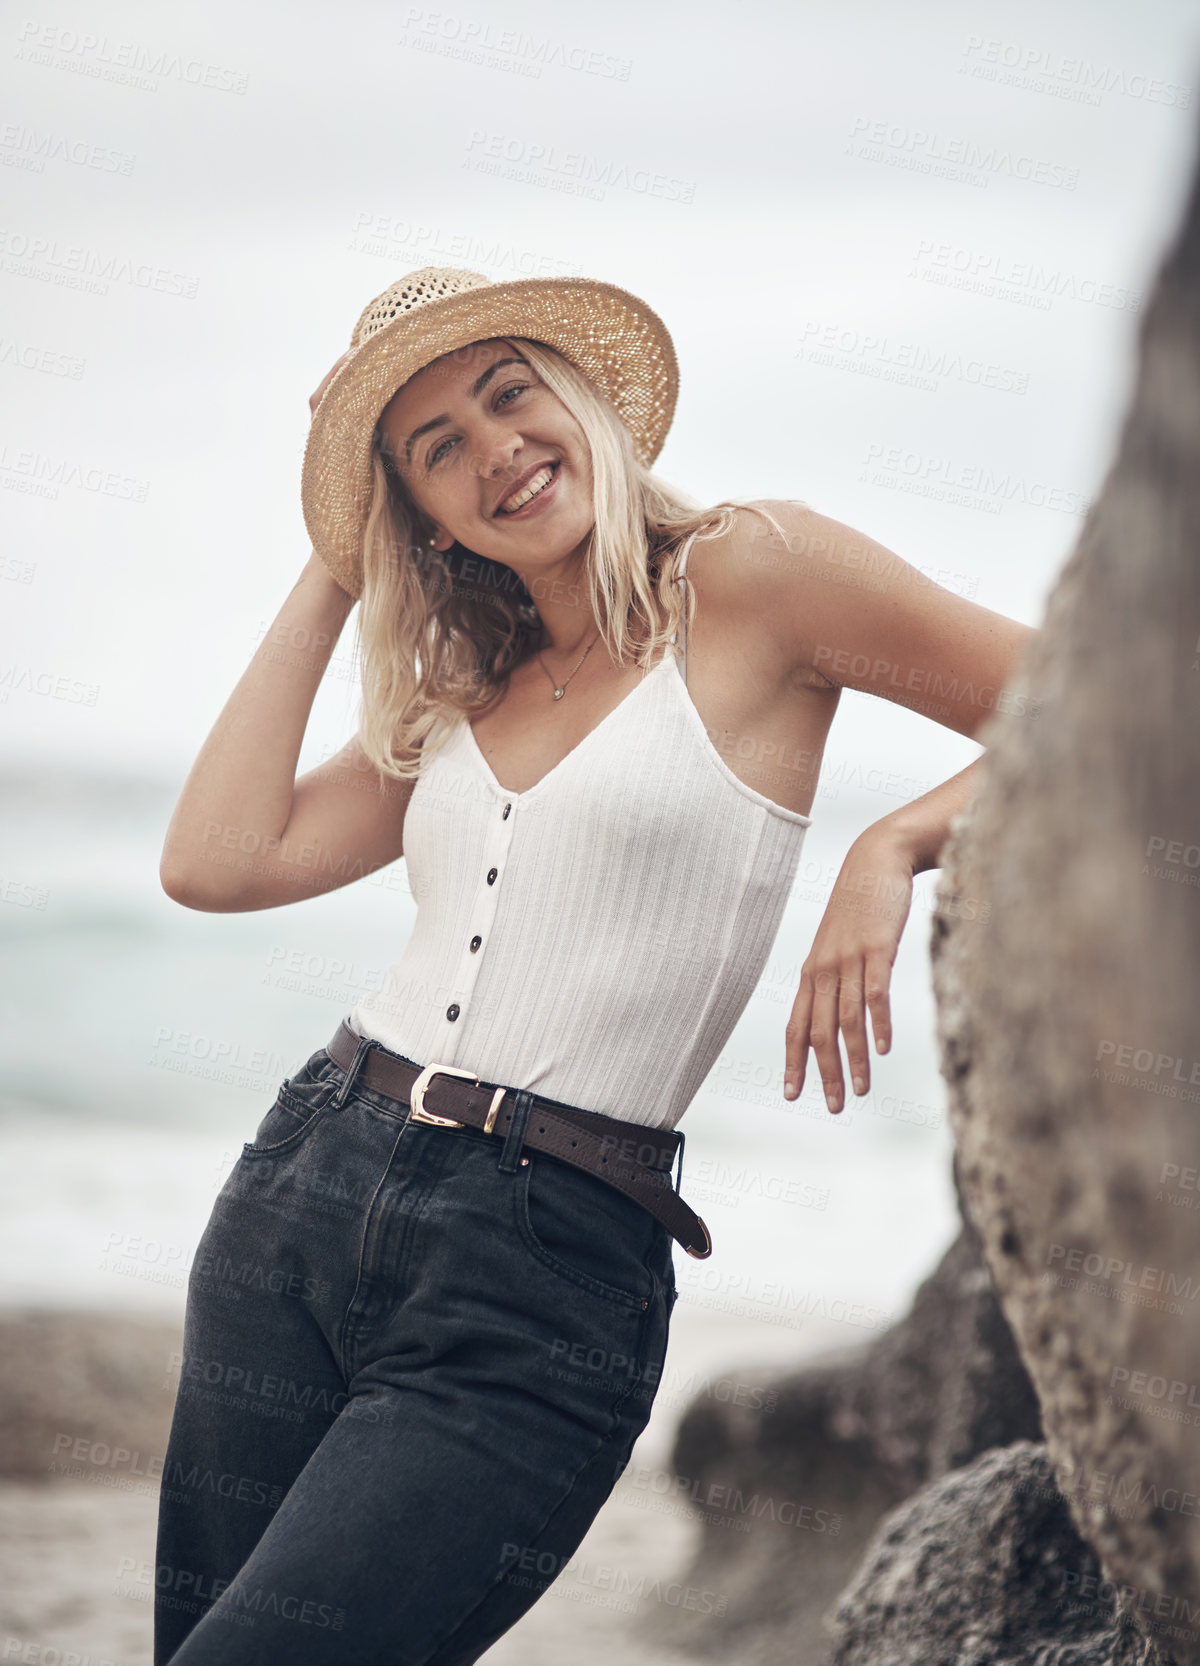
[783,828,913,1115]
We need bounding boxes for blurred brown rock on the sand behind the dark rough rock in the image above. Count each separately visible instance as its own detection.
[652,1228,1040,1666]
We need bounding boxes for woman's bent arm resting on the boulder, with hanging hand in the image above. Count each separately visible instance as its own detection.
[716,501,1037,1111]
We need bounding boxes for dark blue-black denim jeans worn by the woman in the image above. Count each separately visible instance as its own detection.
[153,1048,675,1666]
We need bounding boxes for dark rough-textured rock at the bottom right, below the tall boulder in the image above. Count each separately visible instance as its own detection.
[832,1441,1170,1666]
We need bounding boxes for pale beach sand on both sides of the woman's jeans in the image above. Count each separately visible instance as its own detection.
[0,1296,833,1666]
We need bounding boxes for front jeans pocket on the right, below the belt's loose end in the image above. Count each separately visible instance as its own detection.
[515,1151,658,1309]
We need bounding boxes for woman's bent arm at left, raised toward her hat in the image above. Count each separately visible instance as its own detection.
[158,553,415,913]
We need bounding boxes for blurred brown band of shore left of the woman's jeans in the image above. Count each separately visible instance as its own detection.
[0,1309,183,1486]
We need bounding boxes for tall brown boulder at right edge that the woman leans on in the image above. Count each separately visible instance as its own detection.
[933,104,1200,1666]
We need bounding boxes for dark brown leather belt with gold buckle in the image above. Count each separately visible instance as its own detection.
[325,1018,712,1261]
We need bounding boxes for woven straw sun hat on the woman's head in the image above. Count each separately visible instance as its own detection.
[300,267,678,596]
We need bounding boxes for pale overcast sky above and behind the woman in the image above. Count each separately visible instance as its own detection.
[0,0,1200,793]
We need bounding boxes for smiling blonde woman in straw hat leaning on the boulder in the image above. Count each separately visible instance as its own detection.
[155,268,1027,1666]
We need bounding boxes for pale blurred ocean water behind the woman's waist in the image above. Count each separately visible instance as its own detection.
[0,766,957,1359]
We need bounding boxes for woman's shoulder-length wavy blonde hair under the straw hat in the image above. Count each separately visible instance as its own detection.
[357,337,782,785]
